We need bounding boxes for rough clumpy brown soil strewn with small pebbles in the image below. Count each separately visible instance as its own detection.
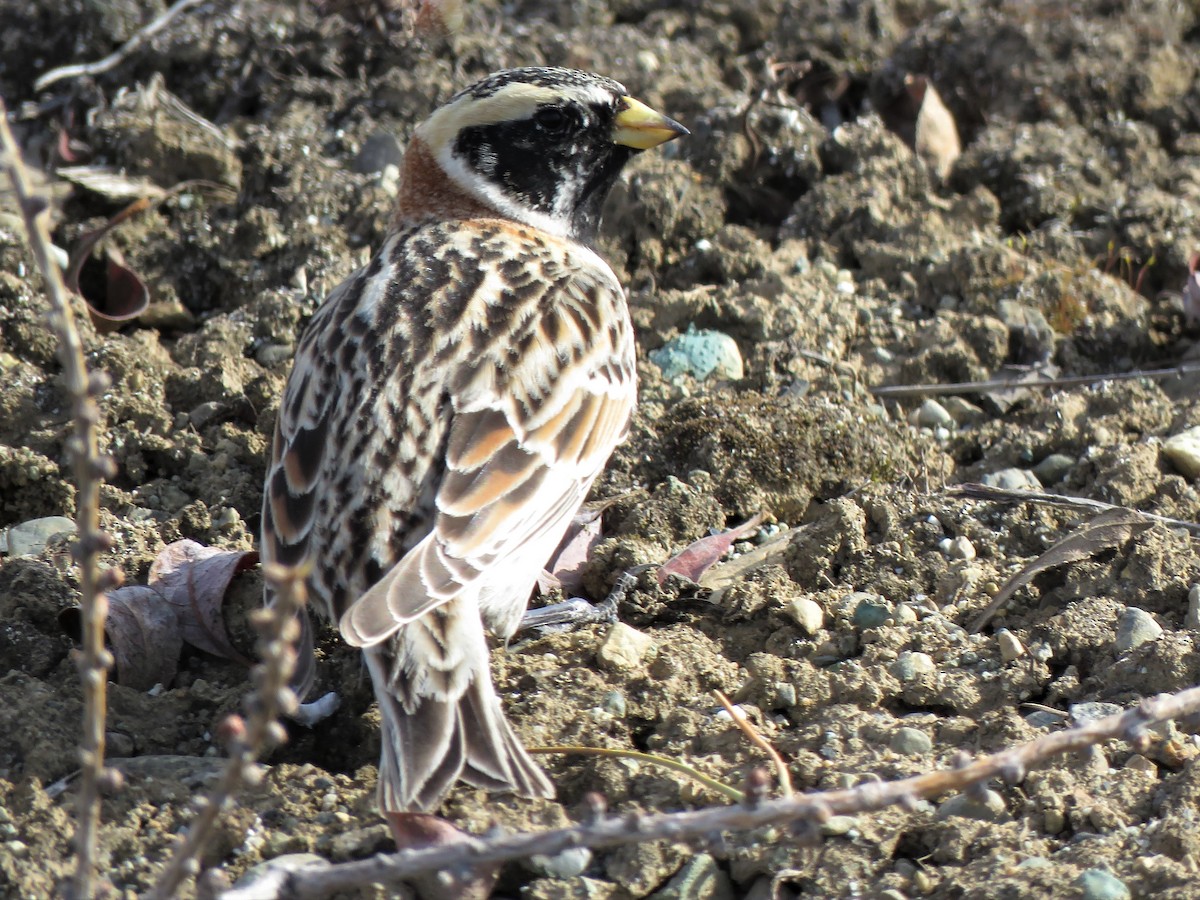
[0,0,1200,900]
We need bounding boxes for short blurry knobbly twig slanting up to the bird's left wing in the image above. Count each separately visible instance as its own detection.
[148,564,305,900]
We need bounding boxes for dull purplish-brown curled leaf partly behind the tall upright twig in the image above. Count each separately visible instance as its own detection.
[59,584,184,690]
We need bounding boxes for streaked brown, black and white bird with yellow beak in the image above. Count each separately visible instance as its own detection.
[262,67,689,814]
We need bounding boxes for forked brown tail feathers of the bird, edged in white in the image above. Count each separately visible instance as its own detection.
[364,643,554,812]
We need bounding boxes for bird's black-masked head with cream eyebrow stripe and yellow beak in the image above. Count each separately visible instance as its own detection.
[414,67,688,242]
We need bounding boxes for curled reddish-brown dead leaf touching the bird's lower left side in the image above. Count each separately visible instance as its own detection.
[149,540,258,666]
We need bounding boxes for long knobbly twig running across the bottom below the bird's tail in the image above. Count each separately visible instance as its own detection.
[217,688,1200,900]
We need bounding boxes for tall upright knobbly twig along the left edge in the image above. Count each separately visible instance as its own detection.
[0,93,121,900]
